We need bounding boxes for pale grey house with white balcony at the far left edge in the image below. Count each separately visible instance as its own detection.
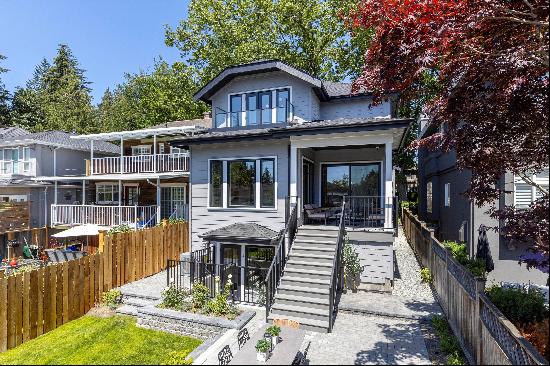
[0,127,118,232]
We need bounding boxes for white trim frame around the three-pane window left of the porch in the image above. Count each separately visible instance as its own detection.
[206,156,279,212]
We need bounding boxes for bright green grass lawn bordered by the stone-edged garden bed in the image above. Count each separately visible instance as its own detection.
[0,316,201,365]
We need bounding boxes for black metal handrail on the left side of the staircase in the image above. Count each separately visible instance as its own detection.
[265,205,298,321]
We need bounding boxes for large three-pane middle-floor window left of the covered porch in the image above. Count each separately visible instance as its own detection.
[208,158,277,209]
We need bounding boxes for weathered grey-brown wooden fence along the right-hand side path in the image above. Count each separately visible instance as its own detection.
[402,209,548,365]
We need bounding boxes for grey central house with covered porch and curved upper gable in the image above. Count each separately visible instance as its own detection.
[173,61,411,329]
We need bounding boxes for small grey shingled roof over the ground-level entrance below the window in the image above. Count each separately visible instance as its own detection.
[199,222,280,243]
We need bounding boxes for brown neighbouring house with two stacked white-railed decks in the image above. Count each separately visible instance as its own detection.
[35,117,210,227]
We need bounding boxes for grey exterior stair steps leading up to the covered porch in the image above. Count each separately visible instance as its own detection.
[267,225,339,333]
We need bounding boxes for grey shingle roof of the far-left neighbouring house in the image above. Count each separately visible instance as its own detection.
[1,131,120,154]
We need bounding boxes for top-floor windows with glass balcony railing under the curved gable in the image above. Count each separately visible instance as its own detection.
[215,88,292,128]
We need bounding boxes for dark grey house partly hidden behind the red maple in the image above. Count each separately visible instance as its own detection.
[418,120,548,285]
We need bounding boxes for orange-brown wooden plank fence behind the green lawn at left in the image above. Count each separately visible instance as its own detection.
[0,223,189,352]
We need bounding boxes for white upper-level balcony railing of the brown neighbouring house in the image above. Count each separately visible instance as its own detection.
[91,153,189,174]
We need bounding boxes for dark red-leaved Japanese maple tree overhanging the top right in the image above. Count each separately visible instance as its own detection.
[347,0,549,271]
